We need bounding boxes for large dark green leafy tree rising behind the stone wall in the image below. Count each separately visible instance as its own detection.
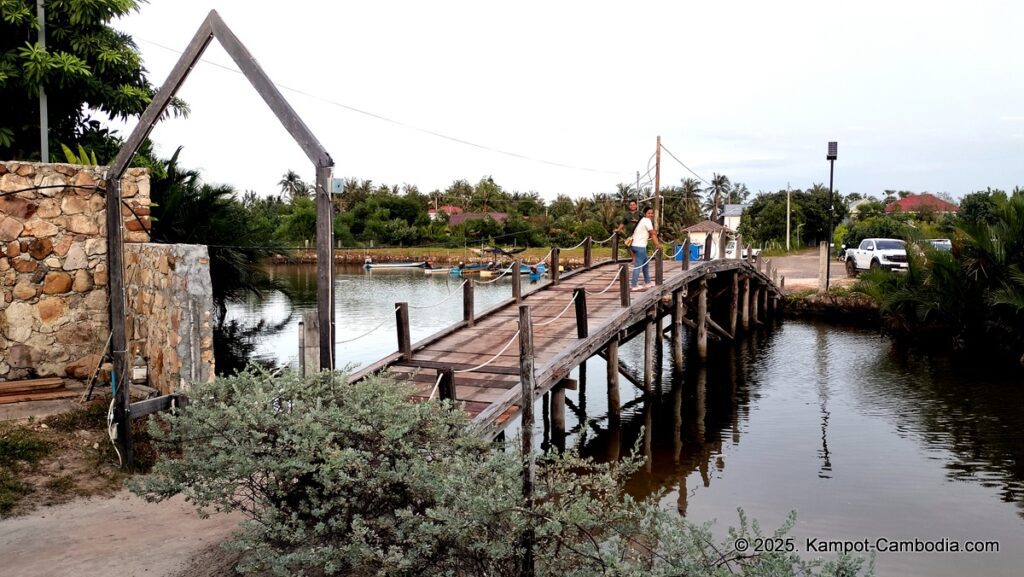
[0,0,188,163]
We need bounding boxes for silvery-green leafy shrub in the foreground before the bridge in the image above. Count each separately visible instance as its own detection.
[131,370,862,577]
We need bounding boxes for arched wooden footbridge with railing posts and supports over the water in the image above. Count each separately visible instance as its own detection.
[350,239,784,438]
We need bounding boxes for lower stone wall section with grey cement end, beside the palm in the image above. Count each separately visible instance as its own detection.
[125,244,215,395]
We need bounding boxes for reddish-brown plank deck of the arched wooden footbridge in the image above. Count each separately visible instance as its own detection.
[351,259,781,437]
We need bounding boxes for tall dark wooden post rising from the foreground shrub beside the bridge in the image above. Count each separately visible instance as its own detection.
[516,303,537,576]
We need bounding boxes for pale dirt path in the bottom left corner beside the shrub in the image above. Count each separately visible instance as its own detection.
[0,491,241,577]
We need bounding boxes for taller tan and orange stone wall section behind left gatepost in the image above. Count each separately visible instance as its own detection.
[0,162,150,380]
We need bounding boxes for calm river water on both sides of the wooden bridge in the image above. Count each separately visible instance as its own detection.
[229,265,1024,576]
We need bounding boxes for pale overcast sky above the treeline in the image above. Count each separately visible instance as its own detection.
[115,0,1024,199]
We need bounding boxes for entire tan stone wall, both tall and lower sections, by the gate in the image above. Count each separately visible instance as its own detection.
[0,162,213,393]
